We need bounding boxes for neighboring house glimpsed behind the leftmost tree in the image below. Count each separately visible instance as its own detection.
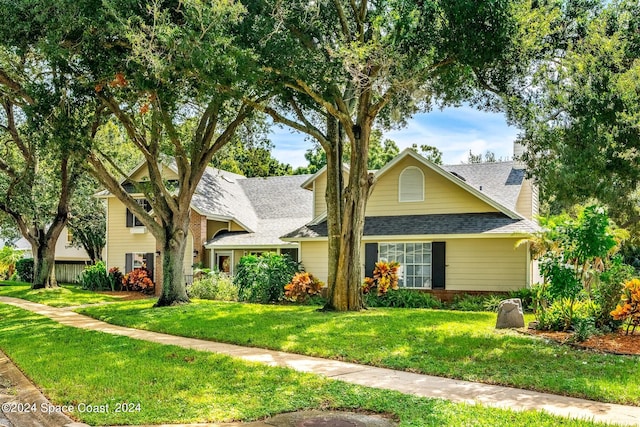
[14,227,91,283]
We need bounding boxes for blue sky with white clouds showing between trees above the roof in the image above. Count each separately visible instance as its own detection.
[270,107,518,168]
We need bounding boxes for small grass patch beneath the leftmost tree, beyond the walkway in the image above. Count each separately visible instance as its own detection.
[0,282,127,307]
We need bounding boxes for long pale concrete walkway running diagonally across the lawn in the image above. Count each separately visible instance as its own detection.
[0,297,640,426]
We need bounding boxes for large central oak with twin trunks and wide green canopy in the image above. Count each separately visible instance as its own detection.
[245,0,536,310]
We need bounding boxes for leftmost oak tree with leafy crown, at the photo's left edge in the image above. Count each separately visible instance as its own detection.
[0,46,93,289]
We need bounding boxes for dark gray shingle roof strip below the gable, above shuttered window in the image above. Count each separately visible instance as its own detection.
[283,212,540,238]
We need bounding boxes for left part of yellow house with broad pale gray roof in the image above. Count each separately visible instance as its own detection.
[96,164,313,290]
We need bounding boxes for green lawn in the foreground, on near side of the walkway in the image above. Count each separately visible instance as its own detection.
[0,304,612,427]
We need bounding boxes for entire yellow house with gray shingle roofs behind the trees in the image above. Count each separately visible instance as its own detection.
[98,144,539,298]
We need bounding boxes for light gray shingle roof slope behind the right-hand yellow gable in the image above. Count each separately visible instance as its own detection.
[442,162,525,210]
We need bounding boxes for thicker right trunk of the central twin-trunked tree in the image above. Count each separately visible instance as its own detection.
[326,121,373,311]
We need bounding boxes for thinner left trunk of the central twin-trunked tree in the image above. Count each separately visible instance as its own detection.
[325,116,344,300]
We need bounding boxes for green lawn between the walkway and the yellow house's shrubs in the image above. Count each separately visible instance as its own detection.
[78,300,640,405]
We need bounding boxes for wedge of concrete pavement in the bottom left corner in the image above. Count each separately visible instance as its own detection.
[0,351,89,427]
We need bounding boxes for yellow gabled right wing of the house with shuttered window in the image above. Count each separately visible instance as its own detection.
[283,149,539,299]
